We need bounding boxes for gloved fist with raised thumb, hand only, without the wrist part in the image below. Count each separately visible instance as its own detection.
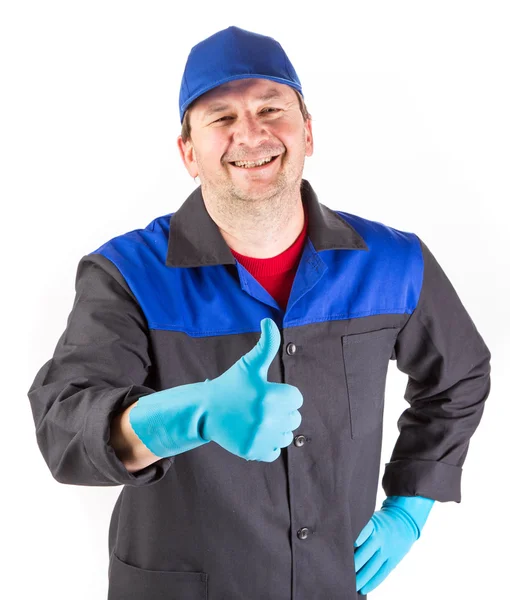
[199,319,303,462]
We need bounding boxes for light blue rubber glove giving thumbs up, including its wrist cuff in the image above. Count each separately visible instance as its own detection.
[129,319,303,462]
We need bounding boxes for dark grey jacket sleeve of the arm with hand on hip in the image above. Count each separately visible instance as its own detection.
[382,240,491,502]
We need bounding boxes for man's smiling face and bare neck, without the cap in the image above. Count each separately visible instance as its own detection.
[178,78,313,258]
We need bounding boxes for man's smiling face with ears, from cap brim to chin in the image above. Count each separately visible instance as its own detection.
[178,79,313,200]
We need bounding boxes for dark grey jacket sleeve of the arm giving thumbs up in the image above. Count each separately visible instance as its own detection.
[28,254,175,486]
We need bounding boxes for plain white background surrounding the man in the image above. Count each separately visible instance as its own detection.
[0,0,510,600]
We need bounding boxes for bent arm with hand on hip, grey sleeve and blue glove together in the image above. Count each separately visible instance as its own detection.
[354,237,490,594]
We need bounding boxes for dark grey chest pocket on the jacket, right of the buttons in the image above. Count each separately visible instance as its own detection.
[342,328,399,439]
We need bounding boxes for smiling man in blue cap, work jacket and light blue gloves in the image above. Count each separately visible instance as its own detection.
[29,27,490,600]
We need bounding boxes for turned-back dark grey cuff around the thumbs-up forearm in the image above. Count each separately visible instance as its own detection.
[83,386,175,487]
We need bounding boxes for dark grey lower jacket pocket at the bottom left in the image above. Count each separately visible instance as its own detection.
[108,554,207,600]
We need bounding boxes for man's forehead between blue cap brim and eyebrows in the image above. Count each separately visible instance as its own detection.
[193,78,297,114]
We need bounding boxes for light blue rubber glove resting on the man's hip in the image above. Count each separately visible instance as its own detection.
[354,496,434,594]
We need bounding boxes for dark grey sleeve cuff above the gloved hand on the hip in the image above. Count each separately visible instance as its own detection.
[382,459,462,502]
